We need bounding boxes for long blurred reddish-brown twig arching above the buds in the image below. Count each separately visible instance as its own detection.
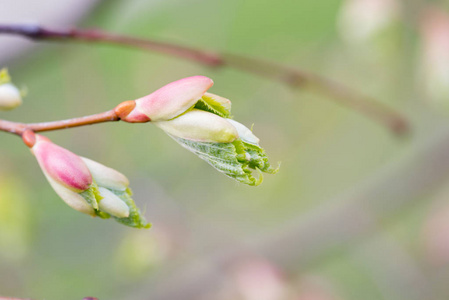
[0,24,409,135]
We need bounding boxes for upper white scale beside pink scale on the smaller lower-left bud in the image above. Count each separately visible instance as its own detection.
[81,157,129,191]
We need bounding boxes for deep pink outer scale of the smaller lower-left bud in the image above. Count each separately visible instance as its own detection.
[31,135,92,192]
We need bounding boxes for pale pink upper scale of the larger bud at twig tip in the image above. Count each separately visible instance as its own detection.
[122,76,214,122]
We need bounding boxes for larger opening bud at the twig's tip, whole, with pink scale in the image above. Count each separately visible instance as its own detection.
[116,76,277,185]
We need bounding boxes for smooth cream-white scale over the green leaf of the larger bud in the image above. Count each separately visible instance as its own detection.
[155,109,238,143]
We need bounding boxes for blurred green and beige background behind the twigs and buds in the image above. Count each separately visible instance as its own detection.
[0,0,449,300]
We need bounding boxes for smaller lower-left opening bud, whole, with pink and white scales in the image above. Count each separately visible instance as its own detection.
[30,131,151,228]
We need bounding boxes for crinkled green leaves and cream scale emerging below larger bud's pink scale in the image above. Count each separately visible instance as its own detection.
[153,81,278,185]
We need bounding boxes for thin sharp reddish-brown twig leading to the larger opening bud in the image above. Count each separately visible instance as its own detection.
[0,110,120,136]
